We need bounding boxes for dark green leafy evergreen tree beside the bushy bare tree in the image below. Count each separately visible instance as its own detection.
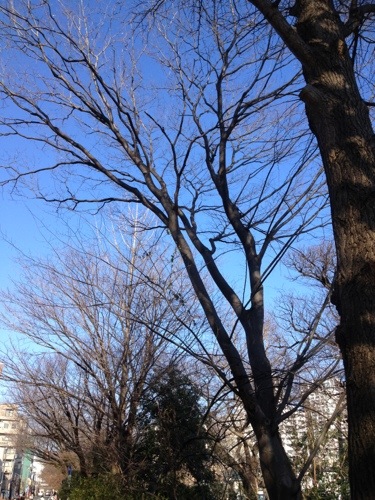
[137,365,219,499]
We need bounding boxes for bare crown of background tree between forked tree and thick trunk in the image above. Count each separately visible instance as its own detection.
[269,242,342,390]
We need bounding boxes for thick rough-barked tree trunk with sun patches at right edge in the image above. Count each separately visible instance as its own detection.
[294,0,375,499]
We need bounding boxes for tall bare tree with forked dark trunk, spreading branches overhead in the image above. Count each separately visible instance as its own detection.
[0,2,350,499]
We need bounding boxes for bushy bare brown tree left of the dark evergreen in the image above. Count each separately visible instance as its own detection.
[2,216,194,482]
